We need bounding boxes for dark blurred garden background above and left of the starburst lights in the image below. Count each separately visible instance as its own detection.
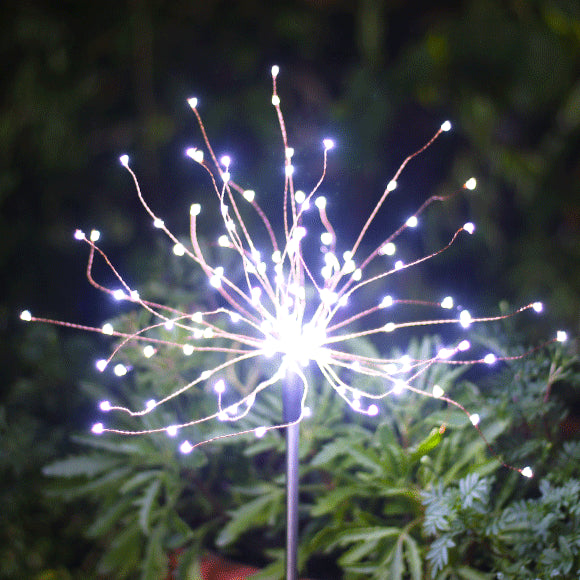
[0,0,580,569]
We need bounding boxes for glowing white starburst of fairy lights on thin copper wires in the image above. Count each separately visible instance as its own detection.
[21,67,566,477]
